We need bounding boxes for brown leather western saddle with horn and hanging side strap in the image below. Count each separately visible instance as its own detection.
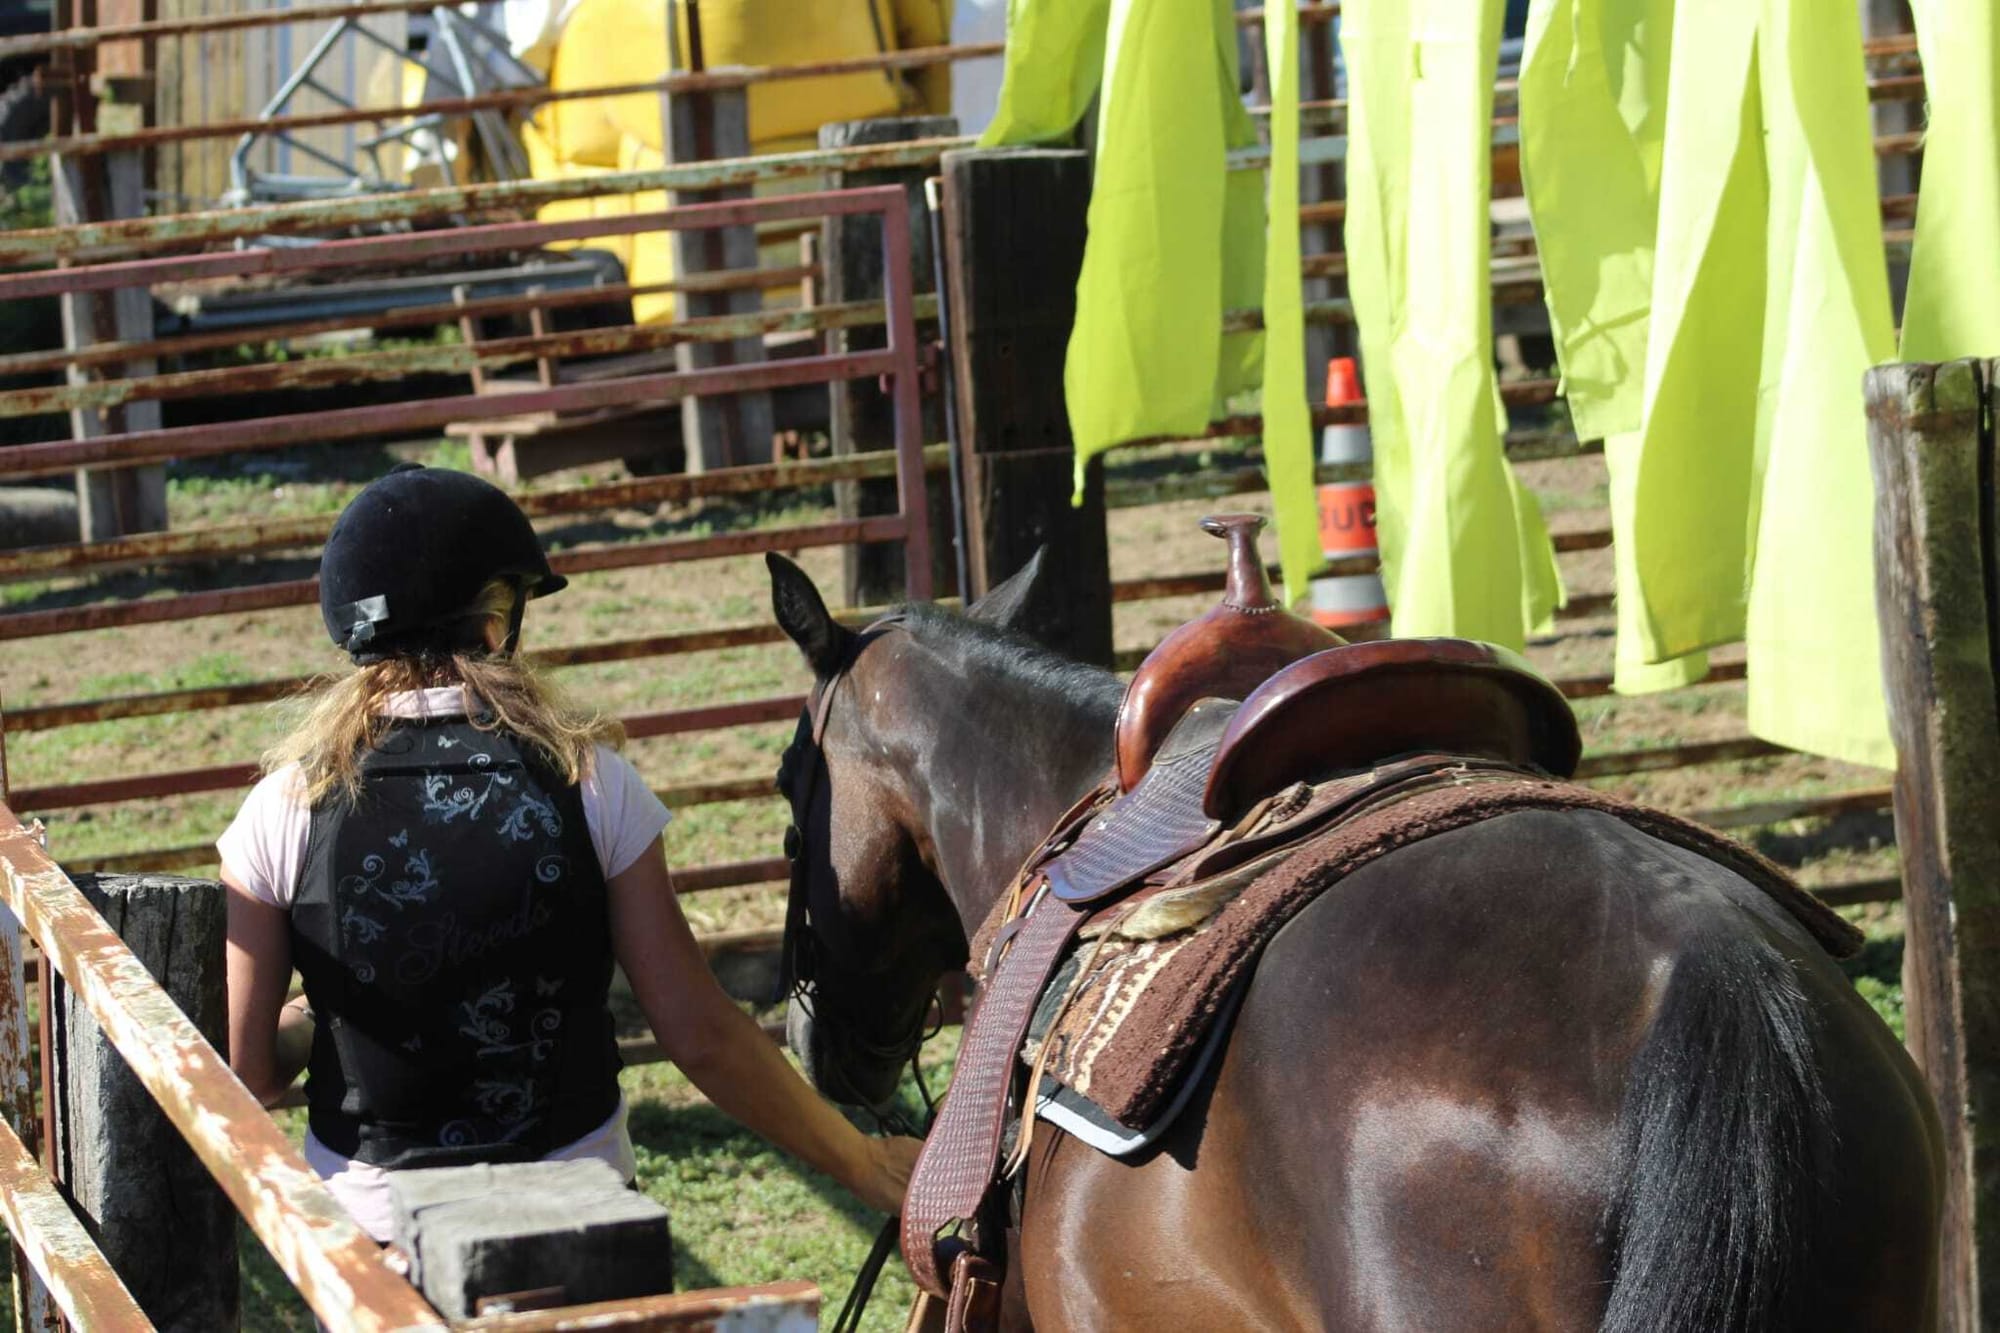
[902,514,1580,1329]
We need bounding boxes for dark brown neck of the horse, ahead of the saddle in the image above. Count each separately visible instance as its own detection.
[906,640,1120,941]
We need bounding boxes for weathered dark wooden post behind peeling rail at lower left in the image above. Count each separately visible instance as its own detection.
[44,875,238,1333]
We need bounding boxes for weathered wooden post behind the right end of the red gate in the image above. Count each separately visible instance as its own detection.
[818,116,958,606]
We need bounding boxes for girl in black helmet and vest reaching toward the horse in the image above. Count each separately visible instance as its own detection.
[216,464,918,1241]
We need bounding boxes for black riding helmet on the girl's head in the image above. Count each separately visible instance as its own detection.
[320,462,570,664]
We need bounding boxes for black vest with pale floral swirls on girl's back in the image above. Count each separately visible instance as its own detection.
[292,719,620,1169]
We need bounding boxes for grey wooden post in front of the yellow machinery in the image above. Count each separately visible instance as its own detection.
[660,75,776,472]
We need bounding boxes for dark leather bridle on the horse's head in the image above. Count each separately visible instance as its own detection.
[776,612,936,1127]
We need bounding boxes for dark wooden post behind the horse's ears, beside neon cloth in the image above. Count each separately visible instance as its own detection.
[942,148,1112,667]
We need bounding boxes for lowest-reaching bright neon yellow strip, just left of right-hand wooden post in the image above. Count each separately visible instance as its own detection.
[1746,0,1896,769]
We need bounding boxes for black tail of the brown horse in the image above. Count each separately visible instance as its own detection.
[1600,929,1832,1333]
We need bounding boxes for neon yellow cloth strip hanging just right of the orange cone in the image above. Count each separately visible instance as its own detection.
[1340,0,1562,648]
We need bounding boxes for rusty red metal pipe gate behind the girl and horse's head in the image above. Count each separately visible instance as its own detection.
[0,188,946,912]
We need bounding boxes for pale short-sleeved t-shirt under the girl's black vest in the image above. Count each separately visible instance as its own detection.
[216,685,672,1241]
